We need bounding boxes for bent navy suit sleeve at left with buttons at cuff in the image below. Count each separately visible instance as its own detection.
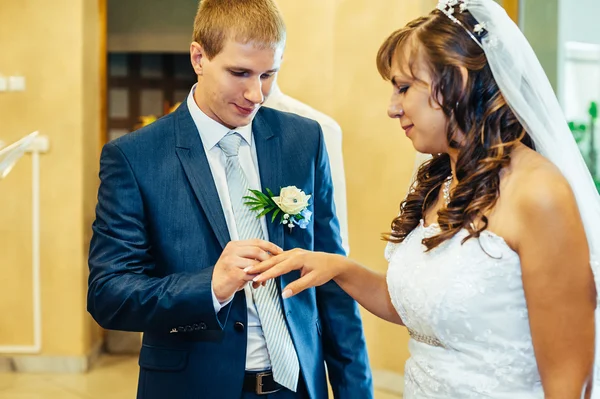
[87,143,222,333]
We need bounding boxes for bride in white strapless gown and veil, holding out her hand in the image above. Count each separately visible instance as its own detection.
[247,0,600,399]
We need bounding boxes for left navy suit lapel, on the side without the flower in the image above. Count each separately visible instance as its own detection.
[175,101,230,248]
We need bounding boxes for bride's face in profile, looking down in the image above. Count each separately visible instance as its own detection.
[388,46,448,154]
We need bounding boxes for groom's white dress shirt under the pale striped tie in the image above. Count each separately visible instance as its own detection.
[187,85,271,371]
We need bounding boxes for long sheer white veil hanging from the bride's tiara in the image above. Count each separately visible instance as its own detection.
[438,0,600,398]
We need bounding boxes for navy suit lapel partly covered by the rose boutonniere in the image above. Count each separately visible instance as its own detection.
[252,111,283,252]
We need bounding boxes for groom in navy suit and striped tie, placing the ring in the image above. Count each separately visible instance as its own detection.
[88,0,373,399]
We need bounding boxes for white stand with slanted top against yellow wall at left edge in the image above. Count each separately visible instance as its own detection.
[0,132,50,353]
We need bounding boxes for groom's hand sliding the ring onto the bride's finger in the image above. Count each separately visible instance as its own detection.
[212,239,282,302]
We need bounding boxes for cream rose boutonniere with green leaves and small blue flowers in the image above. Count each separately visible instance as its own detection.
[244,186,312,232]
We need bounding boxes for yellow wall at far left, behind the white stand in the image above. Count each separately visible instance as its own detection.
[0,0,100,357]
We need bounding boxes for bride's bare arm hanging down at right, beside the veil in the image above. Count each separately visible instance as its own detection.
[515,171,596,399]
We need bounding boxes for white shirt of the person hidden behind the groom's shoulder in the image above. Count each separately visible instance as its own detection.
[263,84,350,255]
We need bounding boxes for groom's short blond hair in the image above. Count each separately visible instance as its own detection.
[193,0,286,59]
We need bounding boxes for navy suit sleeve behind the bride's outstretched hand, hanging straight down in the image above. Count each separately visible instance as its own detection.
[314,127,373,399]
